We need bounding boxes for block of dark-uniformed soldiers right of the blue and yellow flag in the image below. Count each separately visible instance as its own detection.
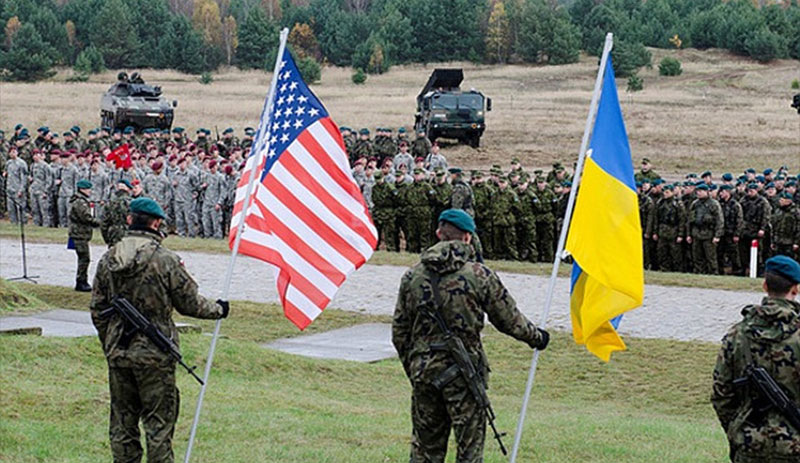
[635,159,800,275]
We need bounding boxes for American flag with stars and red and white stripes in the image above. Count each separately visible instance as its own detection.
[229,49,377,329]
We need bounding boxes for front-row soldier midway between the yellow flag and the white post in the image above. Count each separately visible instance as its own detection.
[686,185,725,275]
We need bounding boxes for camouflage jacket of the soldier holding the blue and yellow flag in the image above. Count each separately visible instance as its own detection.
[392,241,541,382]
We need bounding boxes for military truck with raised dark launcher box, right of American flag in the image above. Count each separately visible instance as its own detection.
[414,69,492,148]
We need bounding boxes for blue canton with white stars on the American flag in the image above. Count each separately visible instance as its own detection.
[250,48,328,180]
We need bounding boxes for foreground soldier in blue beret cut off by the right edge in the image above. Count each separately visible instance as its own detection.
[711,256,800,463]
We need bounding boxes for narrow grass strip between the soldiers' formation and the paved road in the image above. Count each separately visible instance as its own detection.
[0,220,761,292]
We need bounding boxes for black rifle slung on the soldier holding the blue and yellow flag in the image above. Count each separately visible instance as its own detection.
[419,274,508,455]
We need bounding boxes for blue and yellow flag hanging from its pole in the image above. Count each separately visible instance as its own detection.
[566,56,644,362]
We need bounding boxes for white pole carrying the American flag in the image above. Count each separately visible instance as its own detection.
[183,28,289,463]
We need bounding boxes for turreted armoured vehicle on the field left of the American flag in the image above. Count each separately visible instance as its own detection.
[100,72,178,132]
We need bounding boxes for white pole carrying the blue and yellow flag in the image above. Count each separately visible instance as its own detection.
[510,32,614,463]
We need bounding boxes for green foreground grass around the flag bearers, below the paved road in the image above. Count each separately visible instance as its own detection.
[0,280,727,463]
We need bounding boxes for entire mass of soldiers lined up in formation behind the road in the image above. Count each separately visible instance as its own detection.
[0,125,800,275]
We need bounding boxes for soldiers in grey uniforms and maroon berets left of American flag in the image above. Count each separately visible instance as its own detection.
[0,125,250,238]
